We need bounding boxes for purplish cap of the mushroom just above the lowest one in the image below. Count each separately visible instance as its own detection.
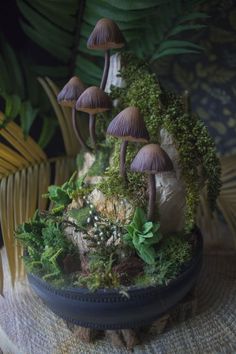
[107,107,149,143]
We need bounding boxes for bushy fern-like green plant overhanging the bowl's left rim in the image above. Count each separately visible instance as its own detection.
[16,211,79,279]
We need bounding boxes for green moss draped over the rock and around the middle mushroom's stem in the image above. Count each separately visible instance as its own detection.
[99,53,221,229]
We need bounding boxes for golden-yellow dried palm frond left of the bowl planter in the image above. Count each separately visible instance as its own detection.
[0,111,78,292]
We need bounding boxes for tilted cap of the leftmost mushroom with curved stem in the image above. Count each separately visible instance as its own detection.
[57,76,85,107]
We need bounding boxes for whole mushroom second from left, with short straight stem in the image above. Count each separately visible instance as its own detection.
[76,86,112,147]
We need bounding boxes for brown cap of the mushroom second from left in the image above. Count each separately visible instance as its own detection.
[75,86,112,114]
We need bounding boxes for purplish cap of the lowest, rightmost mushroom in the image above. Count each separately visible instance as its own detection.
[130,144,173,174]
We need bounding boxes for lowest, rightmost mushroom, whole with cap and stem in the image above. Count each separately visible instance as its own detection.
[130,144,173,221]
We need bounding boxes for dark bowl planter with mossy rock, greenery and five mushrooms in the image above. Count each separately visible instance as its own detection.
[16,19,220,346]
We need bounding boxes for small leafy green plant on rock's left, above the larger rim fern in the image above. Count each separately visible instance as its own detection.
[44,171,85,213]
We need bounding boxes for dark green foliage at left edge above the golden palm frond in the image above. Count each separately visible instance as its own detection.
[0,37,56,147]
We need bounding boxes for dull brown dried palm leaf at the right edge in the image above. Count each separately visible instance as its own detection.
[198,155,236,247]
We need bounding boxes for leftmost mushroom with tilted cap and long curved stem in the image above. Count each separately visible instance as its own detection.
[57,76,90,150]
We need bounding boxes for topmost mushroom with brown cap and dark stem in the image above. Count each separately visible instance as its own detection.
[87,18,125,90]
